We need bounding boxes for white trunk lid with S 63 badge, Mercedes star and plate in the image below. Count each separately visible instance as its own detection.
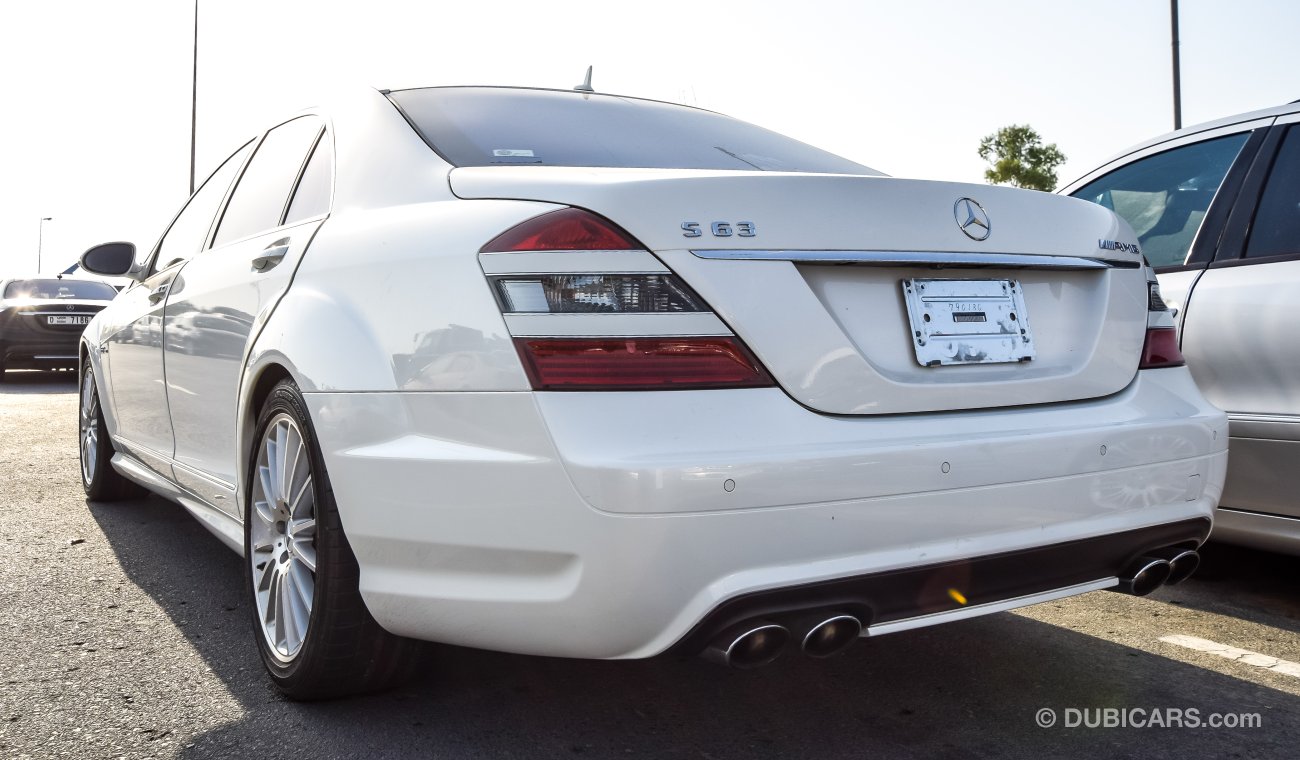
[451,166,1147,414]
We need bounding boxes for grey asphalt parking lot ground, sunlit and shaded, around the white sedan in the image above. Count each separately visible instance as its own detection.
[0,372,1300,760]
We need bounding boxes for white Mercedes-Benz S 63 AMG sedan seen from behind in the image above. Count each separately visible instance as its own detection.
[81,87,1227,699]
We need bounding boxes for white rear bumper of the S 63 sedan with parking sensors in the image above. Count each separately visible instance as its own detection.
[307,369,1227,659]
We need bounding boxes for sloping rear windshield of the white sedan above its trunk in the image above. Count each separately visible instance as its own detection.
[389,87,879,175]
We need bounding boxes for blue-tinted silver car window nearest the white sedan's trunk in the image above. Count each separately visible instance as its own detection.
[1073,133,1251,268]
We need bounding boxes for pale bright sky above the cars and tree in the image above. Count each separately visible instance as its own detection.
[0,0,1300,277]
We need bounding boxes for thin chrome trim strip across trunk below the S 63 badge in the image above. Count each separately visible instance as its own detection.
[690,249,1141,269]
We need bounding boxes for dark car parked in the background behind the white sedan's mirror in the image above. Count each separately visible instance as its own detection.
[0,277,117,381]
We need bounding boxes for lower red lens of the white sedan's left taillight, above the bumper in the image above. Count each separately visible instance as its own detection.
[515,338,772,391]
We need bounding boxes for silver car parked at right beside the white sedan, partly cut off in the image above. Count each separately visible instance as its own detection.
[1061,101,1300,553]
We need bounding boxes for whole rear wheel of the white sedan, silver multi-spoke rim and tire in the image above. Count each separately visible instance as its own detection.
[244,381,424,699]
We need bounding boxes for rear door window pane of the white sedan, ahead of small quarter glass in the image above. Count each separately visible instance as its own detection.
[212,117,321,246]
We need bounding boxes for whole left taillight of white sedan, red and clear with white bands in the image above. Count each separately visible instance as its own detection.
[480,208,775,391]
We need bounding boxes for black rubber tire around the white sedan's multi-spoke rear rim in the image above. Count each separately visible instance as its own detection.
[244,379,426,700]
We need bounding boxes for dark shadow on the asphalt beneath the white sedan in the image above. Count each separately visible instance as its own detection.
[90,496,1300,760]
